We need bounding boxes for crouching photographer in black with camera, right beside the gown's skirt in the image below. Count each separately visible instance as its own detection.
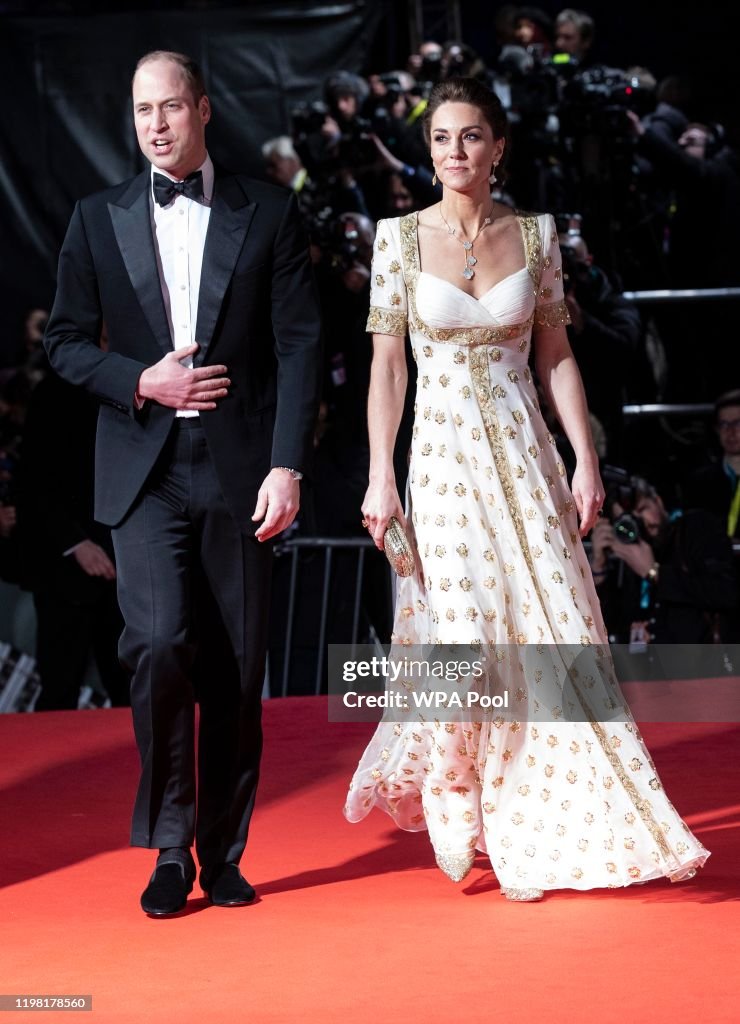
[592,478,737,644]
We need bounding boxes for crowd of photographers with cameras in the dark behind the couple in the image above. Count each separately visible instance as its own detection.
[0,6,740,708]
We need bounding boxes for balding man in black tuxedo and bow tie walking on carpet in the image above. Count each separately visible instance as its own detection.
[45,51,320,915]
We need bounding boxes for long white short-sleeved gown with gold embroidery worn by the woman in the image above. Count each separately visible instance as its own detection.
[345,214,708,890]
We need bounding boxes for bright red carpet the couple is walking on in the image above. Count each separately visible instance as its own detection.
[0,698,740,1024]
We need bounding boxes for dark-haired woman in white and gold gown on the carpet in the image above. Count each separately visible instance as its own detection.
[345,79,708,900]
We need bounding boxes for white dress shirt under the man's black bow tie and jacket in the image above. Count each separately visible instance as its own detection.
[151,155,214,416]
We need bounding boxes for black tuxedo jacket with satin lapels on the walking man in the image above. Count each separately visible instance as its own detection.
[45,169,320,534]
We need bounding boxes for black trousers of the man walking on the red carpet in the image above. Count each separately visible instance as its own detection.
[114,419,272,865]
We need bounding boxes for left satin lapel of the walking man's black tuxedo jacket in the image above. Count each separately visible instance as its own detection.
[107,180,172,360]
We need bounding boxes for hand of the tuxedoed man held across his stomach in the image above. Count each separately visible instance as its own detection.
[137,343,231,412]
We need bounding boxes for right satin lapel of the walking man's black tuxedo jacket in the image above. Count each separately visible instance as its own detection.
[194,177,257,366]
